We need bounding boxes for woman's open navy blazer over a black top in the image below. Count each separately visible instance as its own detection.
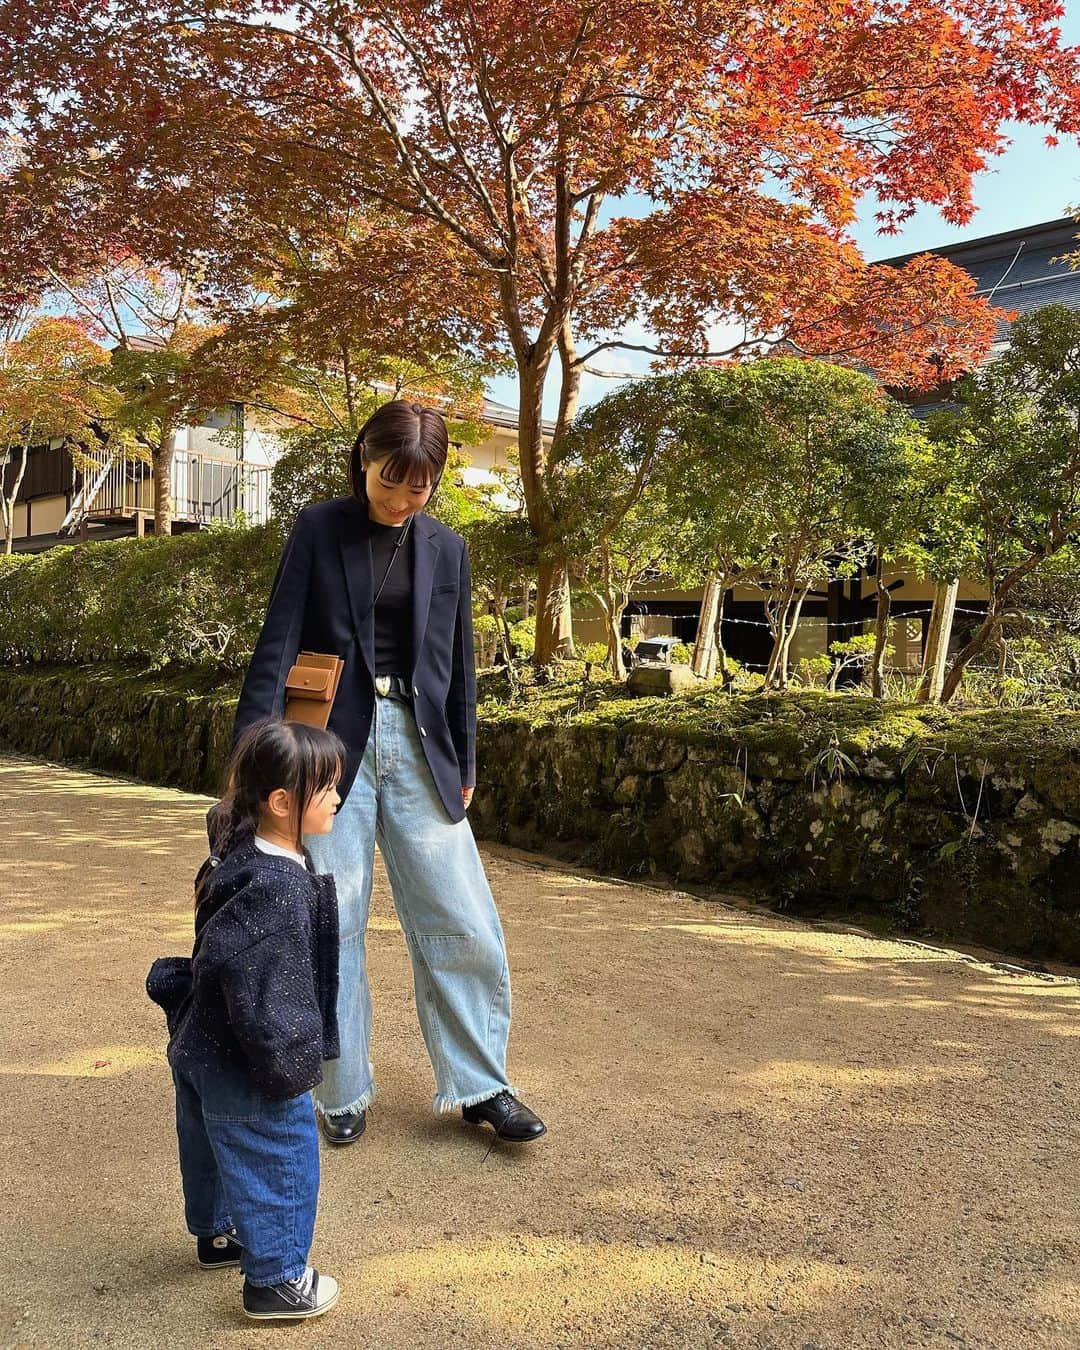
[232,497,477,821]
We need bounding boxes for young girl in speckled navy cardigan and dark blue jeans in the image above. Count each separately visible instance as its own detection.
[147,720,346,1319]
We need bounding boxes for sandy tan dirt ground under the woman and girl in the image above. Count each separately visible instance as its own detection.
[0,759,1080,1350]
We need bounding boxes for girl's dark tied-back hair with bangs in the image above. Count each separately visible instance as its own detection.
[196,717,346,902]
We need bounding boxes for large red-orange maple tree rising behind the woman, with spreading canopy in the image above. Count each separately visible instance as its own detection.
[0,0,1080,660]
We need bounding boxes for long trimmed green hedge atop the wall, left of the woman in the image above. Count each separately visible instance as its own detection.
[0,525,282,671]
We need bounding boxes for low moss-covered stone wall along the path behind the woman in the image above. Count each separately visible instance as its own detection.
[0,666,1080,961]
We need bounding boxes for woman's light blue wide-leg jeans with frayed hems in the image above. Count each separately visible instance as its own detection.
[304,697,513,1115]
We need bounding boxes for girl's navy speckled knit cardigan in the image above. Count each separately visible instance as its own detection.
[146,833,340,1098]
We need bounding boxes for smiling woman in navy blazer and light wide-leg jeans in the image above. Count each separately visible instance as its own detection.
[234,400,545,1143]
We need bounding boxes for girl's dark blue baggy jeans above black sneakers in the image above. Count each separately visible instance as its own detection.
[173,1069,319,1285]
